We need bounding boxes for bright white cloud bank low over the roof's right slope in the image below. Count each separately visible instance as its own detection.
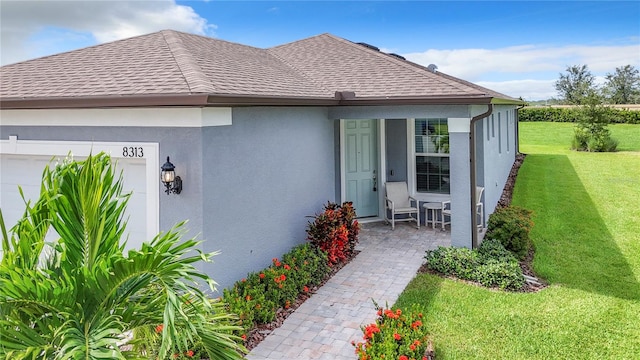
[403,43,640,100]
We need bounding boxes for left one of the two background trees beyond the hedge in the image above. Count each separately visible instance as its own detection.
[555,65,595,105]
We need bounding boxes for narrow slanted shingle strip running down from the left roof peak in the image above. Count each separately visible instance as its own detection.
[160,30,215,93]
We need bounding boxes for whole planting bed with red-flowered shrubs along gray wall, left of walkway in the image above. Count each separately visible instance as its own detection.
[223,203,359,350]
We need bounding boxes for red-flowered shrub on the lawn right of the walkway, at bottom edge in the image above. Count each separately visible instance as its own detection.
[352,304,433,360]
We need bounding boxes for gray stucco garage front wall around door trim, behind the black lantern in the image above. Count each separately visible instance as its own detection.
[0,126,202,240]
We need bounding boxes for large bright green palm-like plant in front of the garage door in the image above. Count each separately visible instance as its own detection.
[0,153,244,359]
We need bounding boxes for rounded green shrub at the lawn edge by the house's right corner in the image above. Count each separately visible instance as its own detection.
[485,206,533,260]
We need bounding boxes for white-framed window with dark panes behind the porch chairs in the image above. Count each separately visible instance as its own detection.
[414,119,450,194]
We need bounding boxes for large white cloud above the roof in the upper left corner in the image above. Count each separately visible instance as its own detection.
[0,0,215,65]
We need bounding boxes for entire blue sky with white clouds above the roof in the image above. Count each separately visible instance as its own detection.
[0,0,640,100]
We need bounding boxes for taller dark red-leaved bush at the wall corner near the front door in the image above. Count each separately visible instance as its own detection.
[307,202,360,265]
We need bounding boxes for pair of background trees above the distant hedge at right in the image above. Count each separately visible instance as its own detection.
[555,65,640,105]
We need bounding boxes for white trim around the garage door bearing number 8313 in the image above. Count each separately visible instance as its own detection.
[0,136,160,239]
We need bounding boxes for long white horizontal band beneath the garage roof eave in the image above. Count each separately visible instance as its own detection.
[0,107,232,127]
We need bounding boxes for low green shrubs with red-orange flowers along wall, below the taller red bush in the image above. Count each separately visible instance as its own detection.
[223,244,330,332]
